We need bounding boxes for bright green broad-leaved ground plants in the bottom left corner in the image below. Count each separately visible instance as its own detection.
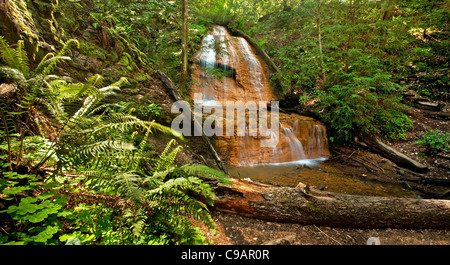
[0,157,70,244]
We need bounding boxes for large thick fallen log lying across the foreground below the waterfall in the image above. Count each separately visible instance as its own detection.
[214,179,450,229]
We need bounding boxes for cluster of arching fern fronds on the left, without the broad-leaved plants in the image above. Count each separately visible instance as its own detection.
[0,38,227,244]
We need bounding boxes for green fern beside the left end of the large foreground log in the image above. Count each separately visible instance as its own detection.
[143,140,229,241]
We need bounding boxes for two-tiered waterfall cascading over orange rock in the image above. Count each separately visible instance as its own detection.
[190,26,329,165]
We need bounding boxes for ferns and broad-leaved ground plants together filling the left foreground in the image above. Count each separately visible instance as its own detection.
[0,34,227,244]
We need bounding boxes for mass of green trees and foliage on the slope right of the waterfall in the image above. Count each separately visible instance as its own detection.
[230,0,449,141]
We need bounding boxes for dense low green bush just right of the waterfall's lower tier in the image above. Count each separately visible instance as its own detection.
[317,71,412,142]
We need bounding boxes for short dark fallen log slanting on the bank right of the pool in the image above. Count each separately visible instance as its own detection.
[363,137,428,172]
